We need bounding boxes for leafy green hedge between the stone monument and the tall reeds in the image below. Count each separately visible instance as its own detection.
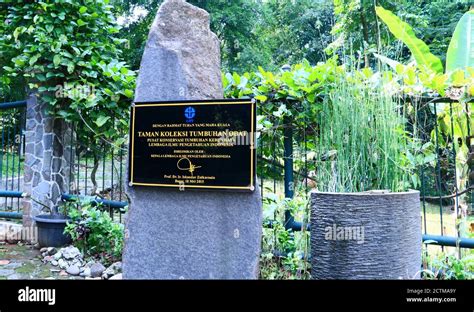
[223,57,344,180]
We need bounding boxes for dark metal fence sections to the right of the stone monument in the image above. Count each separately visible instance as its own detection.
[258,98,474,250]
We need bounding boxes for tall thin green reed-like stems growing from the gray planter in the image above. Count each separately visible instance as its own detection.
[316,77,416,192]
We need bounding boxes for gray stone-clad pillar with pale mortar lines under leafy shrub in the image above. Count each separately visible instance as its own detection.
[23,93,72,226]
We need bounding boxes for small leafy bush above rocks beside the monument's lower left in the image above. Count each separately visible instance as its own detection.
[64,200,124,263]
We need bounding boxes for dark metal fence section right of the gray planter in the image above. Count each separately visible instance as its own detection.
[409,98,474,249]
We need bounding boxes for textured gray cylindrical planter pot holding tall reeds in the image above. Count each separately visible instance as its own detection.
[311,191,422,279]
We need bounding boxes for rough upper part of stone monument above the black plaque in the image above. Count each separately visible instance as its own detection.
[135,0,222,102]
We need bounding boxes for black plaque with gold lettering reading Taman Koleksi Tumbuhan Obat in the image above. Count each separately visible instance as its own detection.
[129,99,256,191]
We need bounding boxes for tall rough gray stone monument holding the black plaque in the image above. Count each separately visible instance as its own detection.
[123,0,262,279]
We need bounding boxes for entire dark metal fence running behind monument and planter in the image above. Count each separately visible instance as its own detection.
[0,91,474,248]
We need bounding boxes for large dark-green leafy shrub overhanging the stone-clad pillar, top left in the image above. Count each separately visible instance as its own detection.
[0,0,135,146]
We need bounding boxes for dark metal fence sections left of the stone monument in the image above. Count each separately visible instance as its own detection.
[0,100,128,222]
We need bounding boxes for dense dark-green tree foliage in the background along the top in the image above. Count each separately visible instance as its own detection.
[112,0,474,72]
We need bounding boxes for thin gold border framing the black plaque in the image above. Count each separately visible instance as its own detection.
[130,100,256,191]
